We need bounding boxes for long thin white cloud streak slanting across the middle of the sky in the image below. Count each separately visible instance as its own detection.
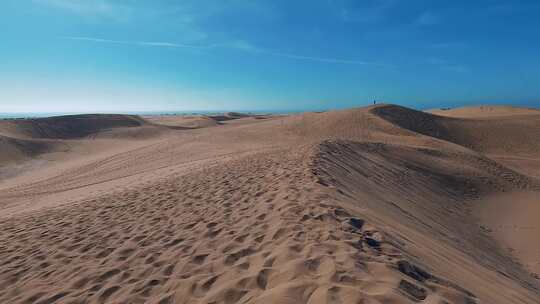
[62,36,390,67]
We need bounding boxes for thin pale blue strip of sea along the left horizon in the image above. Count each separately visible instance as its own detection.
[0,110,303,119]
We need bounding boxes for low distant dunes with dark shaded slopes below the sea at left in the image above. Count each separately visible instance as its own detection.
[0,112,254,164]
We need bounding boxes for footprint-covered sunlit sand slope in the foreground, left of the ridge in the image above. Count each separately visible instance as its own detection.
[2,147,478,303]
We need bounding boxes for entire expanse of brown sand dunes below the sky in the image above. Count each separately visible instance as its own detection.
[0,105,540,304]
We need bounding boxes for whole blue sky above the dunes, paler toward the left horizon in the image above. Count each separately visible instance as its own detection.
[0,0,540,112]
